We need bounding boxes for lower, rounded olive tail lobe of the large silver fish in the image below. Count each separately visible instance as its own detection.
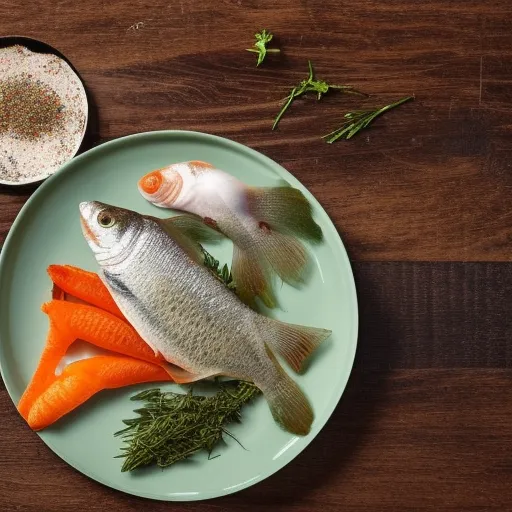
[259,345,314,436]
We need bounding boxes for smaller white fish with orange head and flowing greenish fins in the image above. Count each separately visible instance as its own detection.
[138,161,322,307]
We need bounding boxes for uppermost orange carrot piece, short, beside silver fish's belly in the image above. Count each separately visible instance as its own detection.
[48,265,124,319]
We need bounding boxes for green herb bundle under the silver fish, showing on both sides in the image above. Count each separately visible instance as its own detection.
[114,249,260,472]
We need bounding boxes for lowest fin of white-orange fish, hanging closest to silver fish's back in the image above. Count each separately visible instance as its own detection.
[231,245,277,309]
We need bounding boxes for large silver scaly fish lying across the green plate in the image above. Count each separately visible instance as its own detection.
[80,202,330,435]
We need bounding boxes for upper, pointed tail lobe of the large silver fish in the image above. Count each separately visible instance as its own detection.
[262,317,332,372]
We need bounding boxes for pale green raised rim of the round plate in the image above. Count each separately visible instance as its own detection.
[0,130,359,502]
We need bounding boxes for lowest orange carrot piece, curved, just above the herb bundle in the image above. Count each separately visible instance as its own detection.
[28,356,171,430]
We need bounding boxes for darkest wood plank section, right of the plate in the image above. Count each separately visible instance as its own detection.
[354,262,512,369]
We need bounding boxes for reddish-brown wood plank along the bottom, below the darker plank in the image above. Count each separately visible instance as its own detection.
[0,369,512,512]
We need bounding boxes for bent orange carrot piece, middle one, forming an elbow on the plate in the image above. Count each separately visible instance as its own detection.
[18,300,164,419]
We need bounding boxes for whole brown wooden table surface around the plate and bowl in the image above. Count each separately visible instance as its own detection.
[0,0,512,512]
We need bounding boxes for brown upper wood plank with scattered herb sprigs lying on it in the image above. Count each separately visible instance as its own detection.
[0,0,512,261]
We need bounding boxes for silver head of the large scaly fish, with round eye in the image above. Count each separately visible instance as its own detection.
[79,201,144,265]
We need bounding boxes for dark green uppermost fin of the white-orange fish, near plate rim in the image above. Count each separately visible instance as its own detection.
[247,186,323,243]
